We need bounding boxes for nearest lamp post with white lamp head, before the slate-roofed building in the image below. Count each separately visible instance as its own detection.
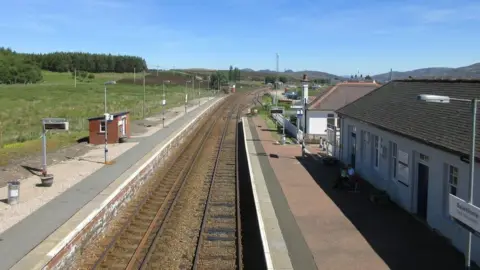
[417,94,478,270]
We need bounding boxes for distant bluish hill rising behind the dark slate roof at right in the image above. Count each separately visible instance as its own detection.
[373,63,480,81]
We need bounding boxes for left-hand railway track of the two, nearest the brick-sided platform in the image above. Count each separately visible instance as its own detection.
[87,96,234,269]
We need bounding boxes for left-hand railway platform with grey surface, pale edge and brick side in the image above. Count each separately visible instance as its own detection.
[0,97,224,269]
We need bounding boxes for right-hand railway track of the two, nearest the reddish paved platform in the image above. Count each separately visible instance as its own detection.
[192,106,243,269]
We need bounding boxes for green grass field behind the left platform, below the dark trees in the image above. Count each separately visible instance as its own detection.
[0,72,212,165]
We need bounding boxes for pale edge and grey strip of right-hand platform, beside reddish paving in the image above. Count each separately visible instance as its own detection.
[243,118,316,270]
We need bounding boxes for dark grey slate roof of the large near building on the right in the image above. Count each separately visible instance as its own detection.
[337,79,480,158]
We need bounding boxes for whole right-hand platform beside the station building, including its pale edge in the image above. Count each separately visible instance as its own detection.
[242,117,470,270]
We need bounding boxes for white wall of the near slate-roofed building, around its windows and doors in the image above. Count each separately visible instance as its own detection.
[340,118,480,264]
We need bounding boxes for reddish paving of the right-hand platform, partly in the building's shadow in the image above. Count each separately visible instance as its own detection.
[251,114,474,270]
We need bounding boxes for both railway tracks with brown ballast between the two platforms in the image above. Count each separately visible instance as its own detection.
[82,92,253,269]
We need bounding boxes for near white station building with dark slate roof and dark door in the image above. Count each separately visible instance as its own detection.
[336,80,480,264]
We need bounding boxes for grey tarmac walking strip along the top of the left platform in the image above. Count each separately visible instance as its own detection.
[0,98,220,270]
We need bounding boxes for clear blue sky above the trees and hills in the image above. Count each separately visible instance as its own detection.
[0,0,480,75]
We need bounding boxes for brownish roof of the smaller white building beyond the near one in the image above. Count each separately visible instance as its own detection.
[309,82,380,111]
